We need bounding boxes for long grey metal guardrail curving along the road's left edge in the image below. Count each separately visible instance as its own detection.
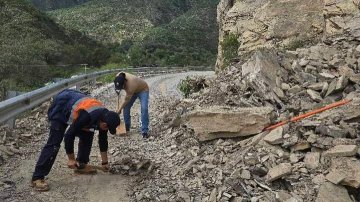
[0,66,211,123]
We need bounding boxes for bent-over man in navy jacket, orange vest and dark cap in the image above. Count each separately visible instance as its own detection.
[32,89,120,191]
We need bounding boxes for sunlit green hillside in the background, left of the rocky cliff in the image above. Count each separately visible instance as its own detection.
[48,0,219,65]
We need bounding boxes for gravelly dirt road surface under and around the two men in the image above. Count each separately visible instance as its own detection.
[0,72,214,202]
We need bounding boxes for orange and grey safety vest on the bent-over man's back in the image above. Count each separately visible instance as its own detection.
[67,97,104,125]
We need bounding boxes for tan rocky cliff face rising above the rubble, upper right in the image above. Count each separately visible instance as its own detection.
[216,0,360,69]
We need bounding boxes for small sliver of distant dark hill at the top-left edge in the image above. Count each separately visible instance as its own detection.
[31,0,89,10]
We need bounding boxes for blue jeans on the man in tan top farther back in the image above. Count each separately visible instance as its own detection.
[123,91,149,134]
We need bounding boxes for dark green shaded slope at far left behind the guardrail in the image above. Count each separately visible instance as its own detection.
[0,0,108,96]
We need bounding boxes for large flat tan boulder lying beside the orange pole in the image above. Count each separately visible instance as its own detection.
[186,106,274,141]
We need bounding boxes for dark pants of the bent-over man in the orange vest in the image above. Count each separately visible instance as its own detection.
[32,121,94,181]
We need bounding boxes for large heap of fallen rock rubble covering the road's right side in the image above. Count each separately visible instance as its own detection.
[128,32,360,202]
